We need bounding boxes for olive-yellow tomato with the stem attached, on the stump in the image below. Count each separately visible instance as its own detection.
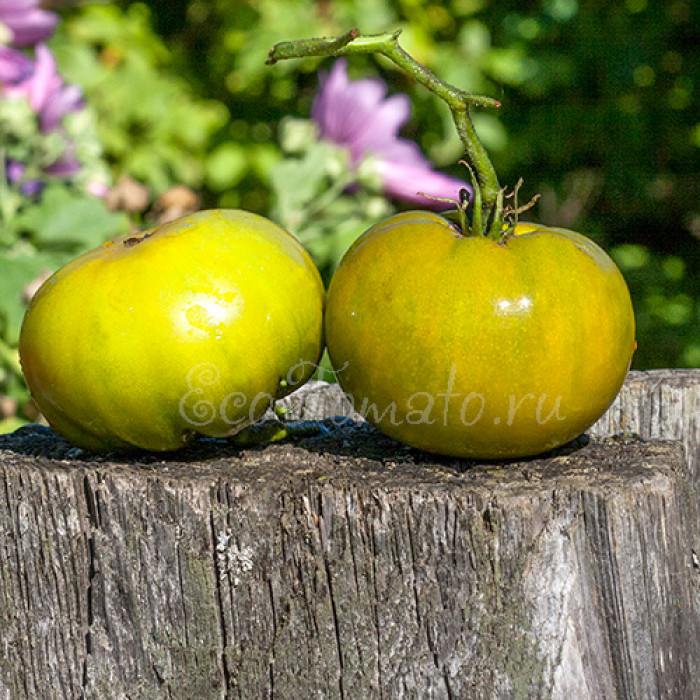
[326,212,635,459]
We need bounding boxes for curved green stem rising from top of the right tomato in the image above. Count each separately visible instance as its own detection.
[267,29,503,239]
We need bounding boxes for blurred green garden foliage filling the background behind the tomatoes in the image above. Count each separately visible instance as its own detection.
[0,0,700,432]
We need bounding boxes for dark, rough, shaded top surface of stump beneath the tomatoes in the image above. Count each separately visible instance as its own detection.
[0,420,683,496]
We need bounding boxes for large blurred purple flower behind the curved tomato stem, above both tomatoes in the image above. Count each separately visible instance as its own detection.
[311,60,472,210]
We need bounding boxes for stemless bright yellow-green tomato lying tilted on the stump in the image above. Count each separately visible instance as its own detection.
[19,210,324,451]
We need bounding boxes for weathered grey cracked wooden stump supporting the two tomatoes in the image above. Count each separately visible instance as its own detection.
[0,371,700,700]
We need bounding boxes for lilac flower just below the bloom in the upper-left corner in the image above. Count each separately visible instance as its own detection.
[0,43,83,132]
